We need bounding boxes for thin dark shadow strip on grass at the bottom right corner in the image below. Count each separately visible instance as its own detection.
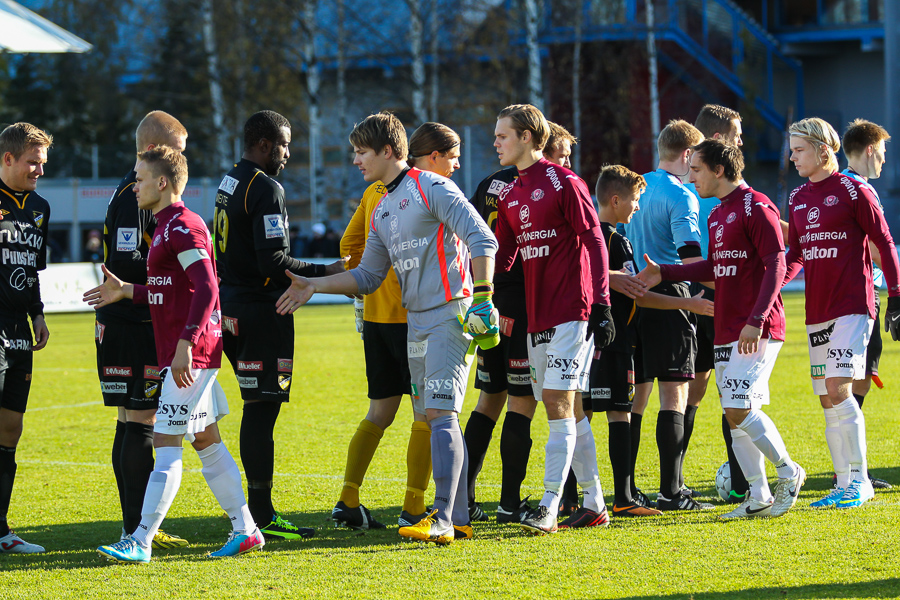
[620,578,900,600]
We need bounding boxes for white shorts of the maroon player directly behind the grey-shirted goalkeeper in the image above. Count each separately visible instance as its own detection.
[528,321,594,399]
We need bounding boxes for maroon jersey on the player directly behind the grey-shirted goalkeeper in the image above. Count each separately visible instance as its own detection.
[497,159,609,332]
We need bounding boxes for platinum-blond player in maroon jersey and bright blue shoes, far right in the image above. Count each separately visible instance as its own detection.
[785,117,900,508]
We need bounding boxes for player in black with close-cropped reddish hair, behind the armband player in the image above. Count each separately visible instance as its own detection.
[94,110,187,548]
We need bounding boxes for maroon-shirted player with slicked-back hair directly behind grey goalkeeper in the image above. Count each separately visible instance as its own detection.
[494,104,615,535]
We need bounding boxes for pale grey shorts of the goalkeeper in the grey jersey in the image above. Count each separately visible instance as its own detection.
[406,298,474,414]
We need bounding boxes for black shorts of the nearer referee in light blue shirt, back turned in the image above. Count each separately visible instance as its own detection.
[637,281,697,381]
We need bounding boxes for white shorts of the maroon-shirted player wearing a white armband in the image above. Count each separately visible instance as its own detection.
[153,368,228,442]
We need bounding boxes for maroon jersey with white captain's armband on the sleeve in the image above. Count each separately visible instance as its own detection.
[134,202,222,369]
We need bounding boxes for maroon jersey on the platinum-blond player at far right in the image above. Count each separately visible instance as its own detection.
[785,173,900,325]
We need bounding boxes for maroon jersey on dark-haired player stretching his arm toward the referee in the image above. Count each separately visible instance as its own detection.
[661,184,785,345]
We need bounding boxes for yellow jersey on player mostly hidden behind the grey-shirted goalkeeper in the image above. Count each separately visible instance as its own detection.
[341,181,406,323]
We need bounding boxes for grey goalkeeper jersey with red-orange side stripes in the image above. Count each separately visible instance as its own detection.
[350,169,497,312]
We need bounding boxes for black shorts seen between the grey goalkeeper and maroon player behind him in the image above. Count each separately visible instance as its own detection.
[475,288,534,396]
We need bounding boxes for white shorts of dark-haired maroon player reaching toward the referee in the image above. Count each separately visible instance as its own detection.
[713,338,784,410]
